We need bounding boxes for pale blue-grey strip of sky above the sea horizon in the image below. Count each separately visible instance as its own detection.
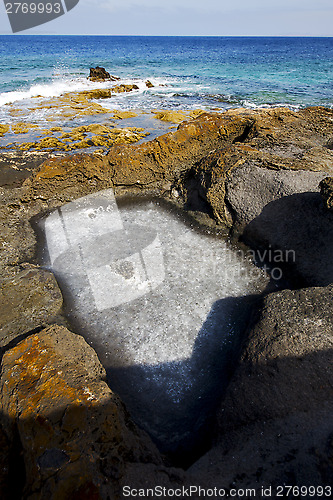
[0,0,333,36]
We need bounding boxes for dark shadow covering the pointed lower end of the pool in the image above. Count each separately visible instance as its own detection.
[104,295,259,467]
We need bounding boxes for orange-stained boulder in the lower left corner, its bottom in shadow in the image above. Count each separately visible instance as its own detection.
[0,326,160,500]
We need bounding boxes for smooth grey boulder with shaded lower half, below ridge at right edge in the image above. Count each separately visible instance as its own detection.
[227,167,333,286]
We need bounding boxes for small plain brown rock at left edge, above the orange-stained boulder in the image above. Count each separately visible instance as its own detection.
[0,266,62,347]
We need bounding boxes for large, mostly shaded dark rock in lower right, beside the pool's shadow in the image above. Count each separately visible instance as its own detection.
[189,286,333,492]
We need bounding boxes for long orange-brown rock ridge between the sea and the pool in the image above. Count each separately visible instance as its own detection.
[26,108,333,206]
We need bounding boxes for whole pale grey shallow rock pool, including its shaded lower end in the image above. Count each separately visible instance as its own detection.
[43,190,267,460]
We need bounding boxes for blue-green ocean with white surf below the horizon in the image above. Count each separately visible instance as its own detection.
[0,35,333,123]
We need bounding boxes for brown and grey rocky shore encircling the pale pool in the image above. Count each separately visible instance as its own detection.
[0,108,333,499]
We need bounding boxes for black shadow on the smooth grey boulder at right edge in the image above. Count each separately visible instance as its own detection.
[242,192,333,286]
